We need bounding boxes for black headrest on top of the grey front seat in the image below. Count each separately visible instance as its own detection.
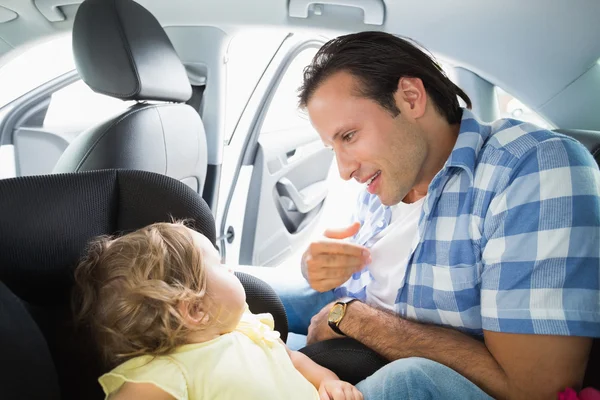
[73,0,192,102]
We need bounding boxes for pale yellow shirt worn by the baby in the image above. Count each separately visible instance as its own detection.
[99,309,319,400]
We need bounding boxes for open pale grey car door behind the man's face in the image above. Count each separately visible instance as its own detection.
[218,35,333,266]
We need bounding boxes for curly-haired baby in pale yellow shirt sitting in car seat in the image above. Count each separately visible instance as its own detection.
[70,223,363,400]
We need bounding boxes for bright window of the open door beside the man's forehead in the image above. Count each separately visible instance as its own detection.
[261,47,318,135]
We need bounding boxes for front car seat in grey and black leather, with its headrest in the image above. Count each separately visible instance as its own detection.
[53,0,208,194]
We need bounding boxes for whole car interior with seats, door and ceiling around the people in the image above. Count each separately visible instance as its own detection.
[0,0,600,399]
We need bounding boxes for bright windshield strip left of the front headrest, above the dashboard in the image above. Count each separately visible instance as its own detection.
[0,34,75,107]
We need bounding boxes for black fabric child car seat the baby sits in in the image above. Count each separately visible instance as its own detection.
[0,170,287,400]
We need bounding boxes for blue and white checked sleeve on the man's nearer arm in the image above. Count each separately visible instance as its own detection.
[481,138,600,337]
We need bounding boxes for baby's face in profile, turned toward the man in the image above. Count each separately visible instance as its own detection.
[191,230,246,329]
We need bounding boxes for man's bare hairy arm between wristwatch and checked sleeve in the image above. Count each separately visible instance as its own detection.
[340,301,592,399]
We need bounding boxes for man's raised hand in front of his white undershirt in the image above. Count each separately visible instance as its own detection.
[302,222,371,292]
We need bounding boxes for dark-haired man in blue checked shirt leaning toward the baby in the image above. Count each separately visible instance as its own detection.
[251,32,600,399]
